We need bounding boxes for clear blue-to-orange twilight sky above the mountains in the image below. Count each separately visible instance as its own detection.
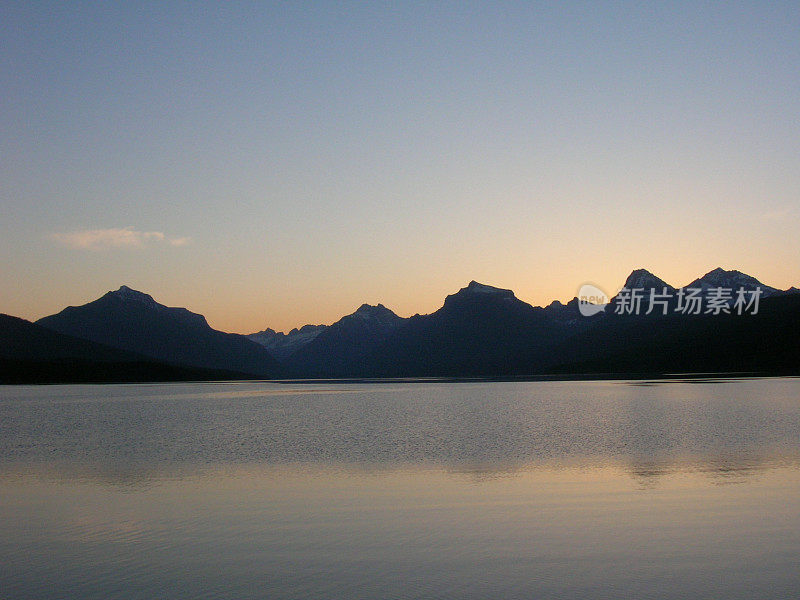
[0,1,800,333]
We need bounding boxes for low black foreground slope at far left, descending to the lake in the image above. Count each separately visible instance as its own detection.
[0,314,247,383]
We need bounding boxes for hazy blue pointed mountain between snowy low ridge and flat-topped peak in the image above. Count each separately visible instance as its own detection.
[287,304,406,377]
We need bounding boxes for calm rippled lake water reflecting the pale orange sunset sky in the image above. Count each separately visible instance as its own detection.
[0,379,800,600]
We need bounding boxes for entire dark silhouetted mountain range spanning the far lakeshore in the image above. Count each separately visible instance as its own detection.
[0,269,800,383]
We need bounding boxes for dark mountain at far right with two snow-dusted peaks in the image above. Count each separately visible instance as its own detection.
[548,268,800,374]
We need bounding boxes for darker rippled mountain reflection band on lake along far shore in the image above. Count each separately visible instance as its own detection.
[0,379,800,487]
